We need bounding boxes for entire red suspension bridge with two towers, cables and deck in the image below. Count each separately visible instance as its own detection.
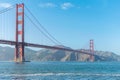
[0,3,95,62]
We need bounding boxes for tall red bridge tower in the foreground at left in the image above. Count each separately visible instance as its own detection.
[15,4,25,62]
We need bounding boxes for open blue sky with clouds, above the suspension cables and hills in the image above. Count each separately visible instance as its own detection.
[0,0,120,54]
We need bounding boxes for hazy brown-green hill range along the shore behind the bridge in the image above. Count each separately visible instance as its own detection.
[0,46,120,61]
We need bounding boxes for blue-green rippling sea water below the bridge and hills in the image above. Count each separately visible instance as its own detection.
[0,62,120,80]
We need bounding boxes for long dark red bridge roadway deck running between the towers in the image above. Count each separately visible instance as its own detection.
[0,40,95,56]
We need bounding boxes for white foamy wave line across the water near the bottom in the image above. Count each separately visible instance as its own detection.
[0,73,120,77]
